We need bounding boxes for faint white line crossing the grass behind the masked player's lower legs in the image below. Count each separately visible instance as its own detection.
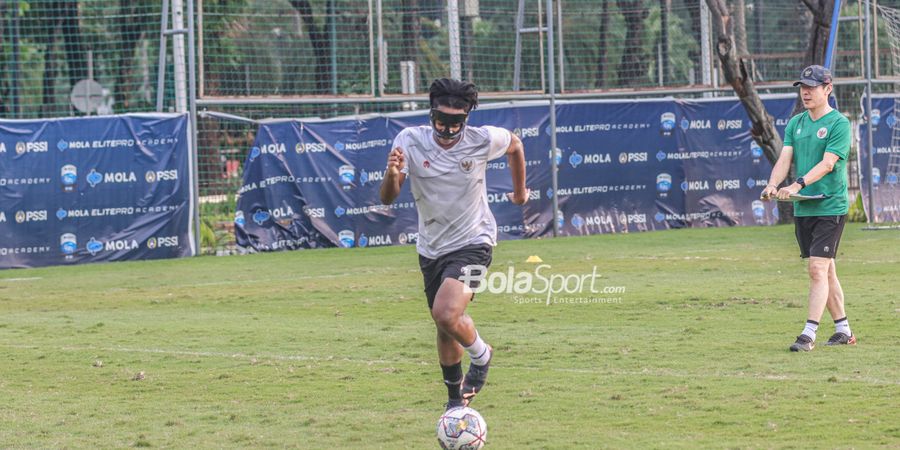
[0,344,900,386]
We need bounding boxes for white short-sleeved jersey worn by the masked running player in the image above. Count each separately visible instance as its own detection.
[392,126,512,259]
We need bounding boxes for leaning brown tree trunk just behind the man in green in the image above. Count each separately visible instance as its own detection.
[706,0,793,223]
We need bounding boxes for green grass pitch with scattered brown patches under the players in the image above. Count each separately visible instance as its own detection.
[0,224,900,449]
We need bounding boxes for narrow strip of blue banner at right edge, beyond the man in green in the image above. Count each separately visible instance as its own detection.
[859,95,900,223]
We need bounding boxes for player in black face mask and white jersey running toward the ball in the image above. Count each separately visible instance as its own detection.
[381,78,528,409]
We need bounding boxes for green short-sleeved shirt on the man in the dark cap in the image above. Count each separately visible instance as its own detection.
[784,109,850,217]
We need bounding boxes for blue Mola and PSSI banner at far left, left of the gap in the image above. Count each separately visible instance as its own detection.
[0,114,194,268]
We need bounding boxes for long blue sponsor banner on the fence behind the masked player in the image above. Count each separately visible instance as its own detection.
[235,95,796,251]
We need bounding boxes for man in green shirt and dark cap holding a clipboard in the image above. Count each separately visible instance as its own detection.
[762,66,856,352]
